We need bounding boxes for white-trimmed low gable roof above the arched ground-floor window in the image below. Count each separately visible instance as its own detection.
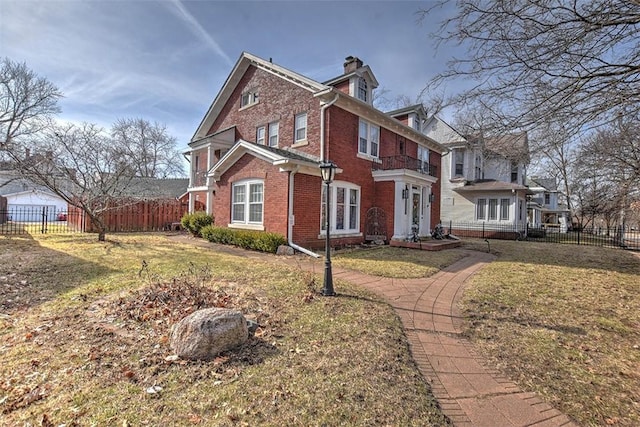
[208,139,324,181]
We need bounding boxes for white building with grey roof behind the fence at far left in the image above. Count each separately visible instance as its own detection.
[0,171,67,222]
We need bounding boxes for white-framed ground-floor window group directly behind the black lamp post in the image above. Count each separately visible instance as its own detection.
[320,181,360,234]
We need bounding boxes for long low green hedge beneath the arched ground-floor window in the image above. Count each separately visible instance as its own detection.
[200,225,287,253]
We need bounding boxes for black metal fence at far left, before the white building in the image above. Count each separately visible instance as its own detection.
[0,206,82,234]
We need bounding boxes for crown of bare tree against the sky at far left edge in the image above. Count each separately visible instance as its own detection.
[0,58,62,150]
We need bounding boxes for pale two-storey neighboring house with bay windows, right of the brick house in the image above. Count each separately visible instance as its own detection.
[423,116,529,230]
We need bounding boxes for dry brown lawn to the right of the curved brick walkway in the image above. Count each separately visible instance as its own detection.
[463,241,640,426]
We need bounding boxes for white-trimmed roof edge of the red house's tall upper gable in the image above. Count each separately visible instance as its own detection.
[191,52,327,142]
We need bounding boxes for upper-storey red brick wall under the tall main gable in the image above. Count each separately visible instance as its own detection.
[209,66,320,156]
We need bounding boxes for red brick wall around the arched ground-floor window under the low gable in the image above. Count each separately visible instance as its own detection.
[213,154,289,237]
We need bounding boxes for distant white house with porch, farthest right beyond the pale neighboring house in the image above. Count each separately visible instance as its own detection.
[527,176,571,233]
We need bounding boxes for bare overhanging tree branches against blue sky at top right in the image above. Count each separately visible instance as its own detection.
[421,0,640,132]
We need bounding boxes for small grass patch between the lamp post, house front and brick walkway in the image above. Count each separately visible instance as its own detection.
[332,246,464,279]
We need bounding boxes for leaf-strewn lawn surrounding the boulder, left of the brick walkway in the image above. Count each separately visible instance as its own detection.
[0,234,449,426]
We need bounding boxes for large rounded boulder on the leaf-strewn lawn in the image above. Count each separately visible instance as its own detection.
[171,308,249,360]
